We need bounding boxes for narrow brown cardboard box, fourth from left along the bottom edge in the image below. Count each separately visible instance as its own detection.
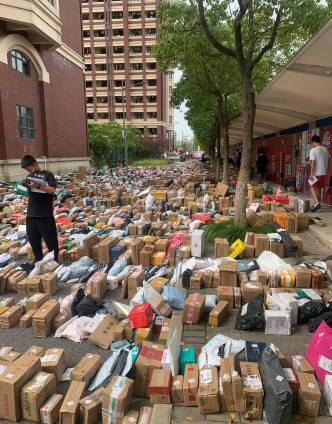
[59,381,85,424]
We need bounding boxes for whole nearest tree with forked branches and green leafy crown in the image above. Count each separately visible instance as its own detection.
[190,0,327,227]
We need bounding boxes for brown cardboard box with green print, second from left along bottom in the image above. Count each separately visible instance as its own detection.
[21,371,56,422]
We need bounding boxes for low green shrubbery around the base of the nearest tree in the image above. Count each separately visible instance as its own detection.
[204,219,274,245]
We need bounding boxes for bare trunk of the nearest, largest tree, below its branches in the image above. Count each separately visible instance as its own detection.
[235,73,256,228]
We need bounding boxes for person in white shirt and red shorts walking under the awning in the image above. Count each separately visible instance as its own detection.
[309,135,329,212]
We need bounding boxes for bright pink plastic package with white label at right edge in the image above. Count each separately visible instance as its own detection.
[305,321,332,385]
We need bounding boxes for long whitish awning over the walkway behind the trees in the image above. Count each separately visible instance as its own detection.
[230,17,332,144]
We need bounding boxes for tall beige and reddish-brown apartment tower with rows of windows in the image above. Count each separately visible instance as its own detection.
[82,0,174,141]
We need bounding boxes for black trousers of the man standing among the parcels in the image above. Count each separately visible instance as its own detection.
[27,216,59,262]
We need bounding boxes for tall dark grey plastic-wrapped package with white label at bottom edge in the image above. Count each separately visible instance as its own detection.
[259,348,293,424]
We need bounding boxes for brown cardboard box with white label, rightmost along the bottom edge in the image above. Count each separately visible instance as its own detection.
[297,372,321,417]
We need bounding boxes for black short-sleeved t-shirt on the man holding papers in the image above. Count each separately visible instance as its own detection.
[26,171,56,217]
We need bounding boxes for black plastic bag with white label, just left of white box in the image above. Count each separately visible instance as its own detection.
[235,294,264,331]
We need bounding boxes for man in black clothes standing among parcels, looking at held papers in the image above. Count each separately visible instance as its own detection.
[21,155,59,262]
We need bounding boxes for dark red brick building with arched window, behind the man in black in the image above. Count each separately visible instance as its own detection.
[0,0,89,181]
